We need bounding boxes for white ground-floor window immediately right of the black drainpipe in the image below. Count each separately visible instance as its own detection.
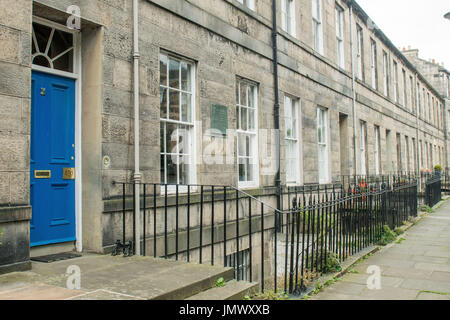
[284,95,301,186]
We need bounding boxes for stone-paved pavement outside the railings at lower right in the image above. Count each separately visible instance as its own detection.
[310,201,450,300]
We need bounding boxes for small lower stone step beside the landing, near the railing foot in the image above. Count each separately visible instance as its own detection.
[186,280,259,300]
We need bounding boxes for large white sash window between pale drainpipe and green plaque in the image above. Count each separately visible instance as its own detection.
[159,51,197,193]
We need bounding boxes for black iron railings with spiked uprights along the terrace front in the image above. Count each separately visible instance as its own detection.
[110,177,417,293]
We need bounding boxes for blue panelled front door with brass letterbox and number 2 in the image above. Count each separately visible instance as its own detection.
[30,71,76,246]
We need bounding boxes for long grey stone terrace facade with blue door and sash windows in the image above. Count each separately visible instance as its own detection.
[0,0,448,270]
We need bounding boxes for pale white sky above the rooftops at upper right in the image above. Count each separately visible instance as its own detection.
[356,0,450,70]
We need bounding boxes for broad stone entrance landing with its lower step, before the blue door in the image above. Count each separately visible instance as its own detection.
[0,255,244,300]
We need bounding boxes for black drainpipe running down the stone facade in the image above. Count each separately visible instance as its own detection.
[272,0,281,226]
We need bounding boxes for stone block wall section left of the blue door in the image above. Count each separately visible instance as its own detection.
[0,0,31,273]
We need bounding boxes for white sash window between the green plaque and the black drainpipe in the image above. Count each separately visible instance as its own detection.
[236,77,259,188]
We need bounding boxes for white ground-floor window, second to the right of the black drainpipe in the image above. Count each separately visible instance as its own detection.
[317,107,330,184]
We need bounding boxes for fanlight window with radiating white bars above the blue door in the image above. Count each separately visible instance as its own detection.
[32,23,74,73]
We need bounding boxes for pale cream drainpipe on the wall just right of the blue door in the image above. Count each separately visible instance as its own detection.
[133,0,142,255]
